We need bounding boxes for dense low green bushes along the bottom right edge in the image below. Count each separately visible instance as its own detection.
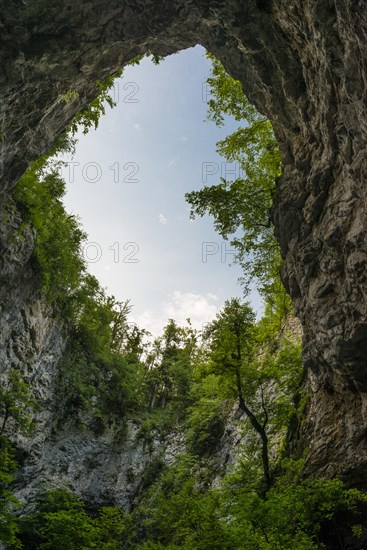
[134,457,367,550]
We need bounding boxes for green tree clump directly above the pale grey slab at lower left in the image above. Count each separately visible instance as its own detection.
[60,275,144,426]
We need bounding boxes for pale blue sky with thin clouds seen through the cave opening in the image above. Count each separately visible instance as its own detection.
[64,46,260,335]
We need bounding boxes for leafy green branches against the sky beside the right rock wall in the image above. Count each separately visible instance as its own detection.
[186,56,280,298]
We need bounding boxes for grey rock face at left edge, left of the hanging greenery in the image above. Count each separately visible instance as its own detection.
[0,200,65,392]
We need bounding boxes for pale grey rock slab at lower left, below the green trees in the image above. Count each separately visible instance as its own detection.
[15,417,184,510]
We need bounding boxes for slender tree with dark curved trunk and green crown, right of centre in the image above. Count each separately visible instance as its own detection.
[205,299,302,496]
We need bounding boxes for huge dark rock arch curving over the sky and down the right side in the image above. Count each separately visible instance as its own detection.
[0,0,367,486]
